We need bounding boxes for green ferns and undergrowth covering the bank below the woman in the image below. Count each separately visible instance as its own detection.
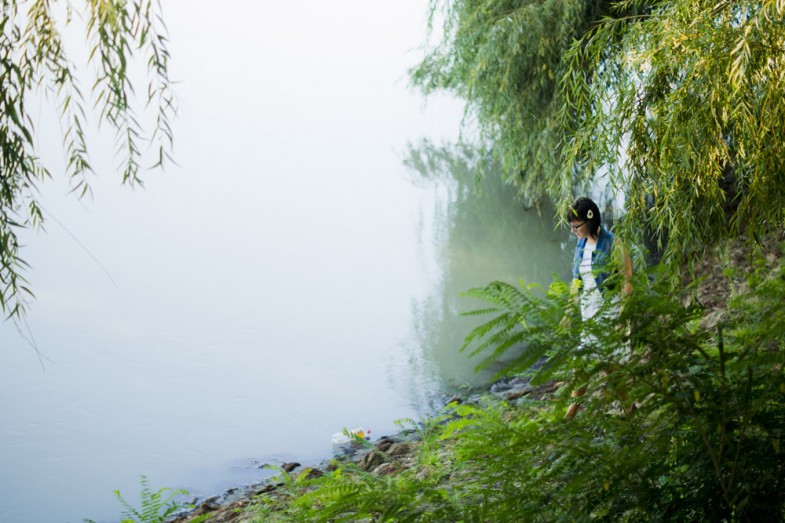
[250,248,785,522]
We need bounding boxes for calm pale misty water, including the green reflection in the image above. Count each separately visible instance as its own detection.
[0,0,569,523]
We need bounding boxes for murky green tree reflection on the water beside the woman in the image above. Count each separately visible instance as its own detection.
[398,141,572,402]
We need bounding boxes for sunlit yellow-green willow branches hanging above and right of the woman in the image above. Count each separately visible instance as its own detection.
[561,0,785,259]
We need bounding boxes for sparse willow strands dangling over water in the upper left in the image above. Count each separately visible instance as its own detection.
[0,0,175,317]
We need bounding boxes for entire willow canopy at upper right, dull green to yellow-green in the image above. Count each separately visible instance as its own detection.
[412,0,785,261]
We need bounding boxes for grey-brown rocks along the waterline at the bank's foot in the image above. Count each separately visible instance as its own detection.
[170,377,561,523]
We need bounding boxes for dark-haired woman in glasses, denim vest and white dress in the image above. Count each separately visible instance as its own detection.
[565,198,632,419]
